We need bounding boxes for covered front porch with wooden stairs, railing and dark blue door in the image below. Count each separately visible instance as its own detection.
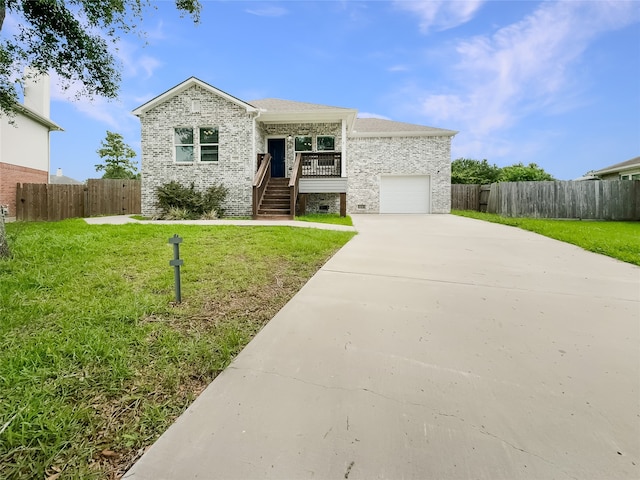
[248,99,356,218]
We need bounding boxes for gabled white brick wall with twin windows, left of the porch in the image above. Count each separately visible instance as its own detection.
[140,86,256,216]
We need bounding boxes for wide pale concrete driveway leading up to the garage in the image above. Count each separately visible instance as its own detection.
[125,215,640,480]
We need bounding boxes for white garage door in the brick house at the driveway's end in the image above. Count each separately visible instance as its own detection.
[380,175,431,213]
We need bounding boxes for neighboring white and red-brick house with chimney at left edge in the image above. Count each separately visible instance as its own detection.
[0,76,62,217]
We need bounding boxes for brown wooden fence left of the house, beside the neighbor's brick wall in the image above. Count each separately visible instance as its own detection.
[16,179,141,221]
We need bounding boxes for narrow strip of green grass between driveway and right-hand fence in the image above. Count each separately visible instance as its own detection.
[451,210,640,265]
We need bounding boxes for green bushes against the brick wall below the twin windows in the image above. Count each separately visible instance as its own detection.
[156,181,228,219]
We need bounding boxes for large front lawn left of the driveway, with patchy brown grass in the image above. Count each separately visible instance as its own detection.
[0,220,353,479]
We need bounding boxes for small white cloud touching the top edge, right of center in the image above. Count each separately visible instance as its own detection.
[394,0,484,33]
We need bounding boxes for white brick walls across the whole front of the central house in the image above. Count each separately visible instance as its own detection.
[134,78,456,216]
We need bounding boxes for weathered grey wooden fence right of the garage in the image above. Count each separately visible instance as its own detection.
[451,180,640,220]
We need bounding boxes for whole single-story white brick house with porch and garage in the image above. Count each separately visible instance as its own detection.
[133,77,457,217]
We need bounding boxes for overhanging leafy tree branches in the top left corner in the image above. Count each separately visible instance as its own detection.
[0,0,201,113]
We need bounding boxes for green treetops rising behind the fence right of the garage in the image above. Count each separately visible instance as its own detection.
[451,158,555,185]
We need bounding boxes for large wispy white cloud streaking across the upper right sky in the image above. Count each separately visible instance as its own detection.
[403,1,640,158]
